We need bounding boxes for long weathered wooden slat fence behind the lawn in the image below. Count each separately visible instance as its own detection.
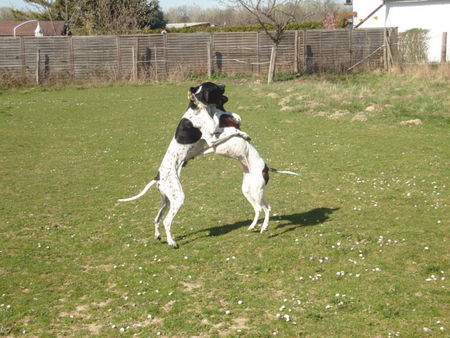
[0,29,395,80]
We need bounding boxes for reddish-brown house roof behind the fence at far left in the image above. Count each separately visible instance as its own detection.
[0,21,66,36]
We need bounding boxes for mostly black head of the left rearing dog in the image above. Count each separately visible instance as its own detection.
[188,82,228,110]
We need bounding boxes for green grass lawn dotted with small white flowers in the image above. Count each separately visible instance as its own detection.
[0,74,450,337]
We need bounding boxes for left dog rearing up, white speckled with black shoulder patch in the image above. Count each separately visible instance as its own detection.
[119,82,250,248]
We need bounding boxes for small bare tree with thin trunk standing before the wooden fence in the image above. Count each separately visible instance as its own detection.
[222,0,302,83]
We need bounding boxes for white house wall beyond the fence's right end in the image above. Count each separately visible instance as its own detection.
[353,0,450,61]
